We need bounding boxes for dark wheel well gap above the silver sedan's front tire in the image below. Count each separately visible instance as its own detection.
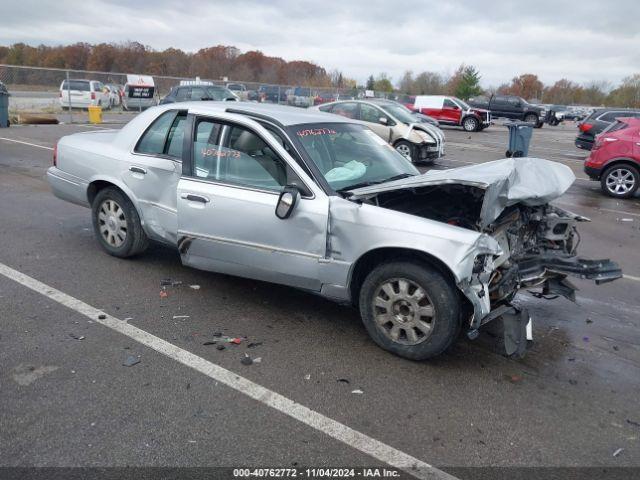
[349,247,468,307]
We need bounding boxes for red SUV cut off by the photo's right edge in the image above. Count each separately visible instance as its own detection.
[584,118,640,198]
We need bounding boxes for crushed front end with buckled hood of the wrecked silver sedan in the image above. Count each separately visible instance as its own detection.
[353,158,622,355]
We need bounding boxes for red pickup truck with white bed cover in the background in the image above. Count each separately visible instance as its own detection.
[407,95,491,132]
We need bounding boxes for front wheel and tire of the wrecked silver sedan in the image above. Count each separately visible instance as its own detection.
[359,261,460,360]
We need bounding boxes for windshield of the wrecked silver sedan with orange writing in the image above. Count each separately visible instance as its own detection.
[289,123,420,191]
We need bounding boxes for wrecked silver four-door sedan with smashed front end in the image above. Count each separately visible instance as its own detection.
[47,102,621,360]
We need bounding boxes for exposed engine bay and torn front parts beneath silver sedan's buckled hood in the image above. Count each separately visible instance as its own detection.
[368,183,622,351]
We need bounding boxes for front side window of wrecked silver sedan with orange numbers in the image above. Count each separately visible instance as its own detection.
[193,119,303,191]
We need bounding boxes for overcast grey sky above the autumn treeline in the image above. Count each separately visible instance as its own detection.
[0,0,640,86]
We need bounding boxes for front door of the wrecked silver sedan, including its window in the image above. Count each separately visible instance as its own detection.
[177,117,328,290]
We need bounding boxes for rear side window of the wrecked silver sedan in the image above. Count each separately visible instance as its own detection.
[135,110,187,160]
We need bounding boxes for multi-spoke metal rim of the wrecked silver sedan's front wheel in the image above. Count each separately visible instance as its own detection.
[373,278,435,345]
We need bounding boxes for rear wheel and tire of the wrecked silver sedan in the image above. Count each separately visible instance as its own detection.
[91,187,149,258]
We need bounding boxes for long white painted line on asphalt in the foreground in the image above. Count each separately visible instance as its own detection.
[0,263,457,480]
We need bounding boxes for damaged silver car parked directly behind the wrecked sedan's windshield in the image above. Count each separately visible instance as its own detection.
[312,98,445,163]
